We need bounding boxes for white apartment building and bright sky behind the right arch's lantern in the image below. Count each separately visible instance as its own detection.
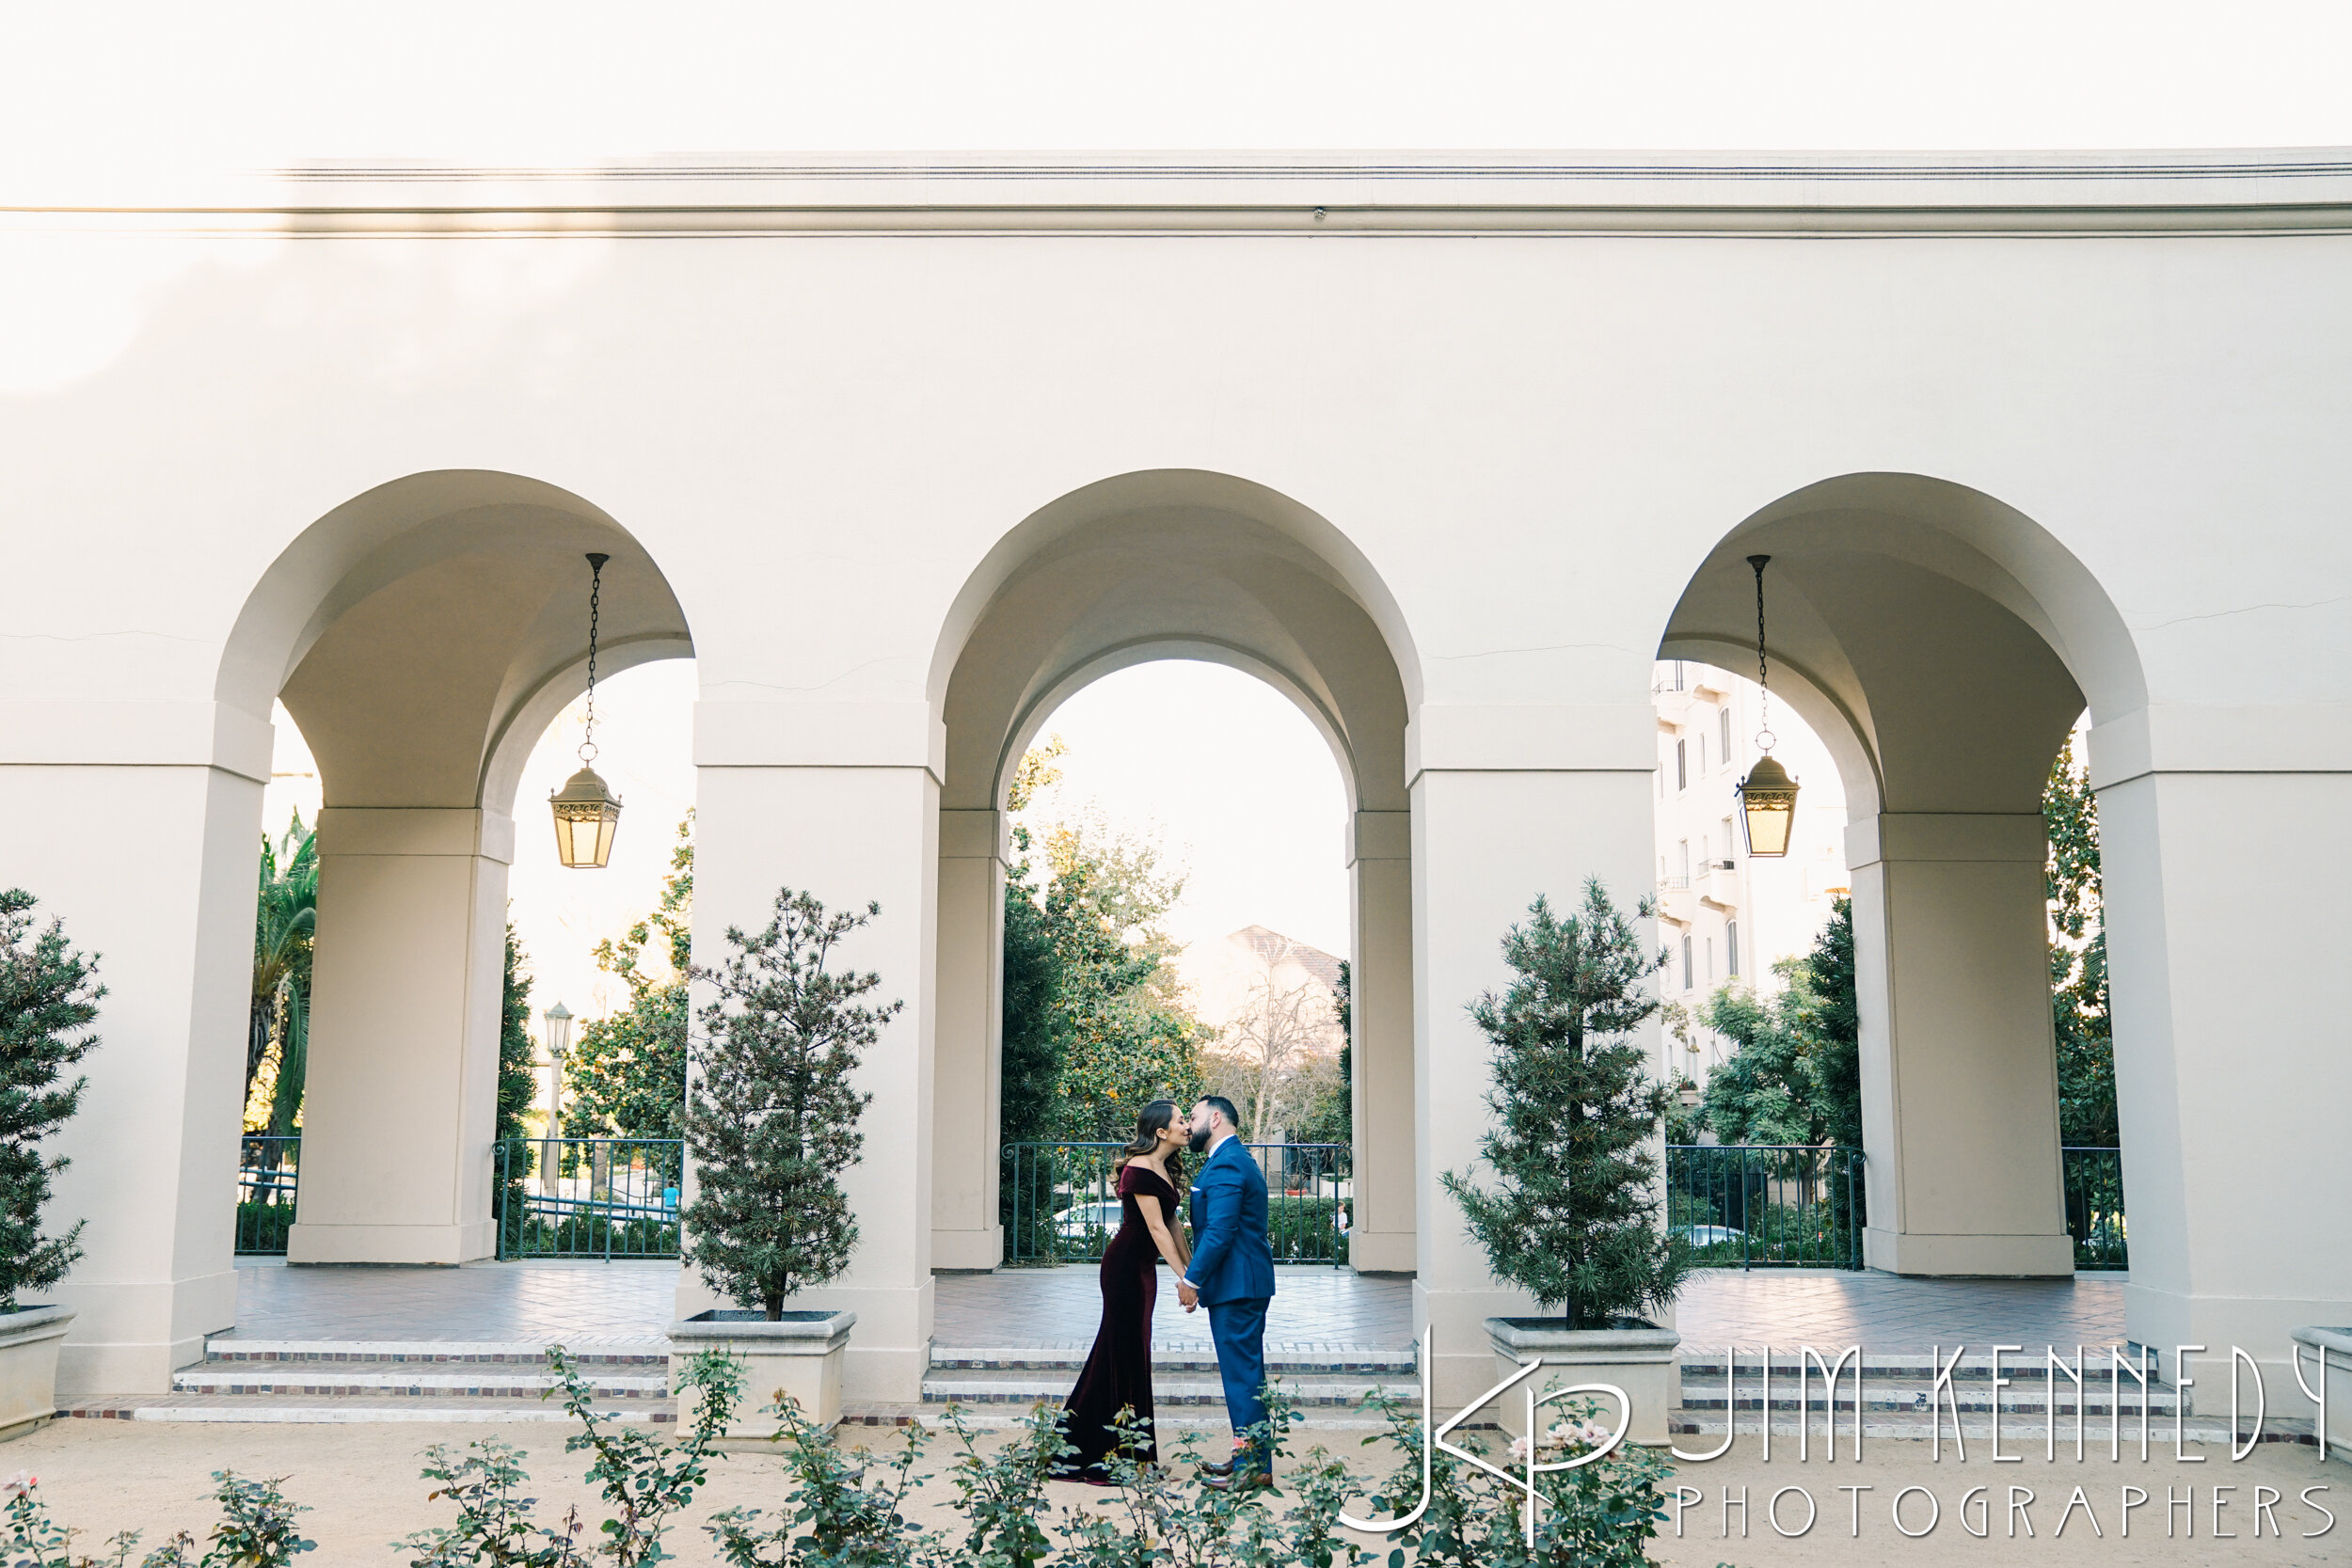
[1651,658,1851,1086]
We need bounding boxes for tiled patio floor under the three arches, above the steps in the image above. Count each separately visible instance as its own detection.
[235,1262,2124,1352]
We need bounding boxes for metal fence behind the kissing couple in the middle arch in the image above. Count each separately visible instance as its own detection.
[1000,1143,1355,1267]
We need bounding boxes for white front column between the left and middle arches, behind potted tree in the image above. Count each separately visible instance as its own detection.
[677,701,936,1403]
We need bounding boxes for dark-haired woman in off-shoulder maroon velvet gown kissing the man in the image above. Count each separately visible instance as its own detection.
[1054,1101,1193,1486]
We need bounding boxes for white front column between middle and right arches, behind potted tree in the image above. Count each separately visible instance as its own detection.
[1406,703,1673,1406]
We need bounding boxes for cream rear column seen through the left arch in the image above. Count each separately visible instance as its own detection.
[287,806,516,1265]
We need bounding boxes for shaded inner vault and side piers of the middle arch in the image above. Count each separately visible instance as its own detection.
[931,470,1414,1270]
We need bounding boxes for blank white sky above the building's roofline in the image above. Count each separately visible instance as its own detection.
[0,0,2352,179]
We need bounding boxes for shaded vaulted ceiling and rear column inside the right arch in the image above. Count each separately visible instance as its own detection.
[1661,475,2145,1275]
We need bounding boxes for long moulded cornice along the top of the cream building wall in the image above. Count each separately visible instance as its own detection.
[13,148,2352,237]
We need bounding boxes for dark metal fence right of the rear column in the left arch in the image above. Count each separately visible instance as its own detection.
[492,1138,685,1260]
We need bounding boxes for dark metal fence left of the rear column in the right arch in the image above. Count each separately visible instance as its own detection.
[1665,1143,1863,1270]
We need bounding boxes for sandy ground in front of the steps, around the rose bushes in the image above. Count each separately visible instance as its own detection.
[0,1420,2352,1568]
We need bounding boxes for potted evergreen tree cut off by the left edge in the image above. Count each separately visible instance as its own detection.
[0,889,106,1439]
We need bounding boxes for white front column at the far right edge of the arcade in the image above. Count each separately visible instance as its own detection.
[2091,747,2352,1382]
